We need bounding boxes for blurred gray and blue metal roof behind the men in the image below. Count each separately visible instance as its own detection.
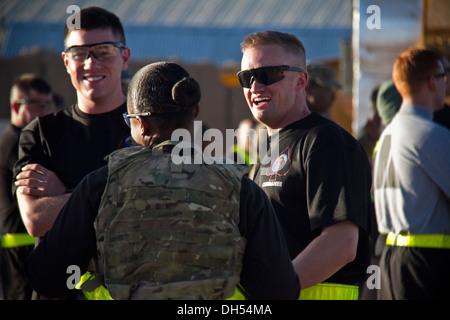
[0,0,352,64]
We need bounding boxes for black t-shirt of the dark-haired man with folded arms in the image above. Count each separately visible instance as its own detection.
[15,103,130,189]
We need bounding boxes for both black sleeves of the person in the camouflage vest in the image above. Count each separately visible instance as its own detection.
[26,166,300,299]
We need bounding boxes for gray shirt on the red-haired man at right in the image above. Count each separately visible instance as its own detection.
[374,105,450,235]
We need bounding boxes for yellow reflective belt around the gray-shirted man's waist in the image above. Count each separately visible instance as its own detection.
[386,232,450,249]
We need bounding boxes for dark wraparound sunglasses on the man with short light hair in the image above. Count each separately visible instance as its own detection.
[237,65,305,88]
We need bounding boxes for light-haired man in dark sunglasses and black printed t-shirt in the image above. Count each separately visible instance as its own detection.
[238,31,371,299]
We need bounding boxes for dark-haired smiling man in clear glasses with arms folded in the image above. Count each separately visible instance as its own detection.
[15,7,130,250]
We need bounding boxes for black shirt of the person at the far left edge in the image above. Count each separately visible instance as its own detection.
[0,125,26,234]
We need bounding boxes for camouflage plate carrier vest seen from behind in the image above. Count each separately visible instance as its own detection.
[94,141,245,299]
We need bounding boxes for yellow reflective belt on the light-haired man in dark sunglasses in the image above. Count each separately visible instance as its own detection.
[298,283,359,300]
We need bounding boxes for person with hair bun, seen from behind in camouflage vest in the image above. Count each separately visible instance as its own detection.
[26,62,300,299]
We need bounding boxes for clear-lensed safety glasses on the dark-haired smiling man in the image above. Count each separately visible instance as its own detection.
[64,42,126,62]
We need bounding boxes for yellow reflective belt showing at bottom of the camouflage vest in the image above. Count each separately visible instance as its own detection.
[75,272,247,300]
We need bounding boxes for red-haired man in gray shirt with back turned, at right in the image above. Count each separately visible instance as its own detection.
[374,49,450,300]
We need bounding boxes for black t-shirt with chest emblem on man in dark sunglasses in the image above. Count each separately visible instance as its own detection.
[254,113,372,284]
